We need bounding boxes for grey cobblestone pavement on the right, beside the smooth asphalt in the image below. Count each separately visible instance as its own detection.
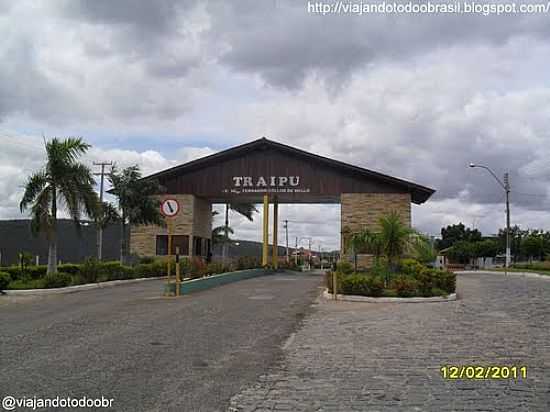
[230,273,550,411]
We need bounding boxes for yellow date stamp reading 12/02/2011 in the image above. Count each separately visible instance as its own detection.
[439,365,527,380]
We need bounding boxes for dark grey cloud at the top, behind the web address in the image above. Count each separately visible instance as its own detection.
[209,1,550,88]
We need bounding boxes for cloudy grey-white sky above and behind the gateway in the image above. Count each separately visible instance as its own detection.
[0,0,550,248]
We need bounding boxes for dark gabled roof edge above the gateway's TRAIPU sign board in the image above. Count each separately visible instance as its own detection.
[144,137,435,204]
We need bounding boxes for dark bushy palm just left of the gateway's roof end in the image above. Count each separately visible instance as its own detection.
[108,165,164,263]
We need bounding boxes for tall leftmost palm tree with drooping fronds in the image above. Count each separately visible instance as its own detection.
[19,137,99,273]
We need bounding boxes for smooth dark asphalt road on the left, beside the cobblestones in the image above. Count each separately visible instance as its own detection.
[0,272,321,411]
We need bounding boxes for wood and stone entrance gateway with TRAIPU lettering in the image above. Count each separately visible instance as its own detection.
[130,138,435,267]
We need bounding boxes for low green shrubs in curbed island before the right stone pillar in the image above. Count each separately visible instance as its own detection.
[326,259,456,298]
